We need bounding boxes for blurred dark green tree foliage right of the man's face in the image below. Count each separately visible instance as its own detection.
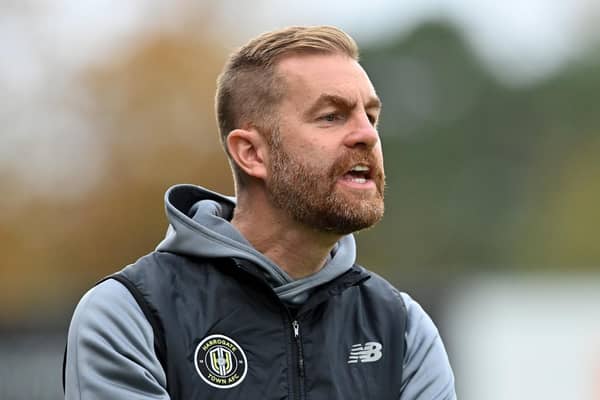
[359,24,600,281]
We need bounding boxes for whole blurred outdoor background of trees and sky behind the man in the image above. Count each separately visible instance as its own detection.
[0,0,600,400]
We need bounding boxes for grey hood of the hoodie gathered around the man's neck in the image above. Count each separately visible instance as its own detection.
[156,185,356,305]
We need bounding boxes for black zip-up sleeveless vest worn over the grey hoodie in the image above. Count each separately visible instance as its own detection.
[111,252,407,400]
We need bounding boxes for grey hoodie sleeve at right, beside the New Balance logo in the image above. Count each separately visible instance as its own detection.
[400,293,456,400]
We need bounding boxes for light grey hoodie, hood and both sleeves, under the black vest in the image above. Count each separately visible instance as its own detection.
[65,185,456,400]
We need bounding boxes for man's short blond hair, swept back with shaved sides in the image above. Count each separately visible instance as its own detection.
[215,26,359,184]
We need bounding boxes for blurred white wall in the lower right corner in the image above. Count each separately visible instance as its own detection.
[443,275,600,400]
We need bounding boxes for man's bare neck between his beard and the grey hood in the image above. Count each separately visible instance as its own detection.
[231,187,341,279]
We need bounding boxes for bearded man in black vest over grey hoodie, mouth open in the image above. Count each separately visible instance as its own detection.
[65,27,456,400]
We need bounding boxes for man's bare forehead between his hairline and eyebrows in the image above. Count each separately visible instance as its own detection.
[276,54,376,103]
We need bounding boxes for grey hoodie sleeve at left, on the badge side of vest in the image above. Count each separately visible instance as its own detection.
[65,279,169,400]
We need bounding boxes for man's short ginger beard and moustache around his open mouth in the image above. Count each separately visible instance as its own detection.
[266,134,385,235]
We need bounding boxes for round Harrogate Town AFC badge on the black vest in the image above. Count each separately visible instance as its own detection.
[194,335,248,389]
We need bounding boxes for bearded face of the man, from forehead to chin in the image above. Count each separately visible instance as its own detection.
[266,55,385,234]
